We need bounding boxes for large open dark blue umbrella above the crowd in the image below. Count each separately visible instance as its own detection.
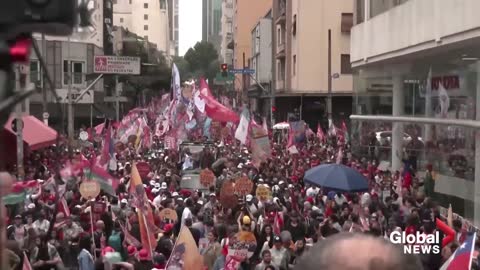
[303,164,368,192]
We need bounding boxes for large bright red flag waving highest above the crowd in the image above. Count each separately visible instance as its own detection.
[200,79,240,123]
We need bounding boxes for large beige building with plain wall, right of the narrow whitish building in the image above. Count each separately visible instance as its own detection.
[272,0,354,125]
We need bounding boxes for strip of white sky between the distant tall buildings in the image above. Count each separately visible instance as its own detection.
[179,0,202,56]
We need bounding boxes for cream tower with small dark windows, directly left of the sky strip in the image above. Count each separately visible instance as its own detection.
[113,0,170,58]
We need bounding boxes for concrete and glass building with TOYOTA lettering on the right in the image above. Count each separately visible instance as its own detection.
[351,0,480,226]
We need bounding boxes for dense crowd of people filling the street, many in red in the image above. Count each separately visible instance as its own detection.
[1,121,479,270]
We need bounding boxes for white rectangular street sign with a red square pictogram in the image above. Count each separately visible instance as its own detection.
[93,55,140,75]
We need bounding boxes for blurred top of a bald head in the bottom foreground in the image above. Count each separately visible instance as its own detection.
[295,233,423,270]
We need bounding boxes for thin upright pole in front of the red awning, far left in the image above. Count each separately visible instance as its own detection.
[12,65,25,181]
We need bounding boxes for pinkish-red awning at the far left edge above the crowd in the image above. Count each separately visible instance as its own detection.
[4,115,57,150]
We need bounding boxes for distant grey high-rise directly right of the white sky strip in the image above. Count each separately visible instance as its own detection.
[202,0,223,55]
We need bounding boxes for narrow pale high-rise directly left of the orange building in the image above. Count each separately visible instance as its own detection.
[219,0,233,65]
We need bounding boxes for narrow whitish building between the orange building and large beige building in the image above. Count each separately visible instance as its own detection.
[248,10,272,118]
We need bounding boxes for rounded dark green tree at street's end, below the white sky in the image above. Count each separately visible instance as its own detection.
[183,41,220,83]
